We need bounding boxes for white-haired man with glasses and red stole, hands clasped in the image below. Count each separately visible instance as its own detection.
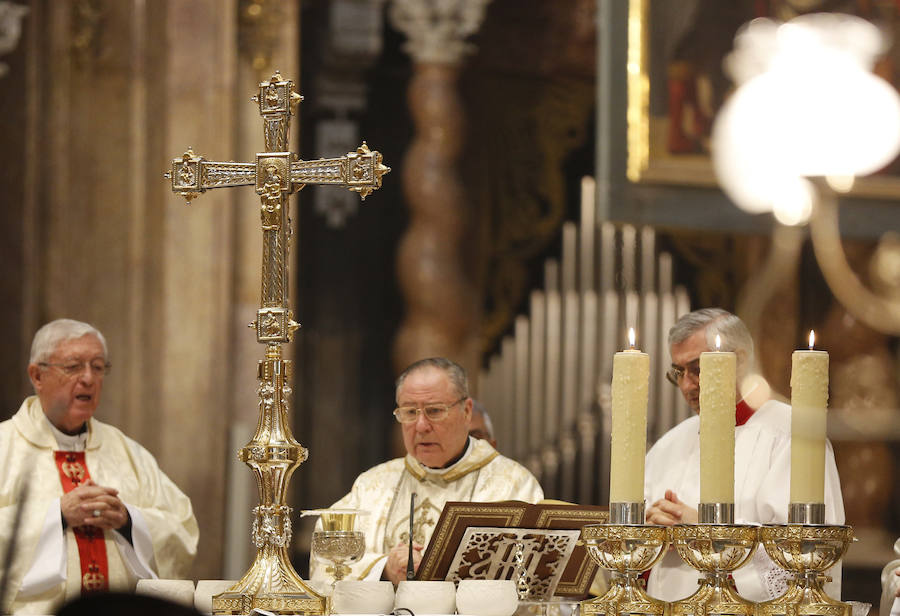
[0,319,198,614]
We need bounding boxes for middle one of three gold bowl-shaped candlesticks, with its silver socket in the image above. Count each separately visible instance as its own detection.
[671,503,758,616]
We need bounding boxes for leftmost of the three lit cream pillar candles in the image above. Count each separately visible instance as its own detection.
[609,329,650,503]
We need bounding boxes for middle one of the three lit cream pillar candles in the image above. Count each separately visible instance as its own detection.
[700,336,737,503]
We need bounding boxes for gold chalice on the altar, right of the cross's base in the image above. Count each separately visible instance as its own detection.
[300,509,368,589]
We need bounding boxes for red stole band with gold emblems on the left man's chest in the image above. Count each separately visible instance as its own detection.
[53,451,109,594]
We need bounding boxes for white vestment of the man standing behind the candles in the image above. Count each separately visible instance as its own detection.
[644,400,844,601]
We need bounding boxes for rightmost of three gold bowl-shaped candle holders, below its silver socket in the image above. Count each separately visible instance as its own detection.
[759,524,853,616]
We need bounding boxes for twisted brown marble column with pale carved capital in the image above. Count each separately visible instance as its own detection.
[390,0,487,372]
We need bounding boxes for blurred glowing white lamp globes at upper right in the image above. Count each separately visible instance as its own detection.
[712,14,900,217]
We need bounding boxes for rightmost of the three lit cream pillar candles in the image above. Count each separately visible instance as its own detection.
[791,332,828,503]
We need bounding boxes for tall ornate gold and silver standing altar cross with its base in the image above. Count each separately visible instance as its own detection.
[166,71,390,614]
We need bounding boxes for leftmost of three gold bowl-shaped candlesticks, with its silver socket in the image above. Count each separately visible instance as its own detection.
[581,503,669,616]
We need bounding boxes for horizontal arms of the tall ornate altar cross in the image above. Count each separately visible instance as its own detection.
[165,141,391,203]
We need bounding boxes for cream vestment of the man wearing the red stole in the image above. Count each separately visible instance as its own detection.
[0,396,198,614]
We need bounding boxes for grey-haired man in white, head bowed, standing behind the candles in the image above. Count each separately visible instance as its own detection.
[644,308,844,601]
